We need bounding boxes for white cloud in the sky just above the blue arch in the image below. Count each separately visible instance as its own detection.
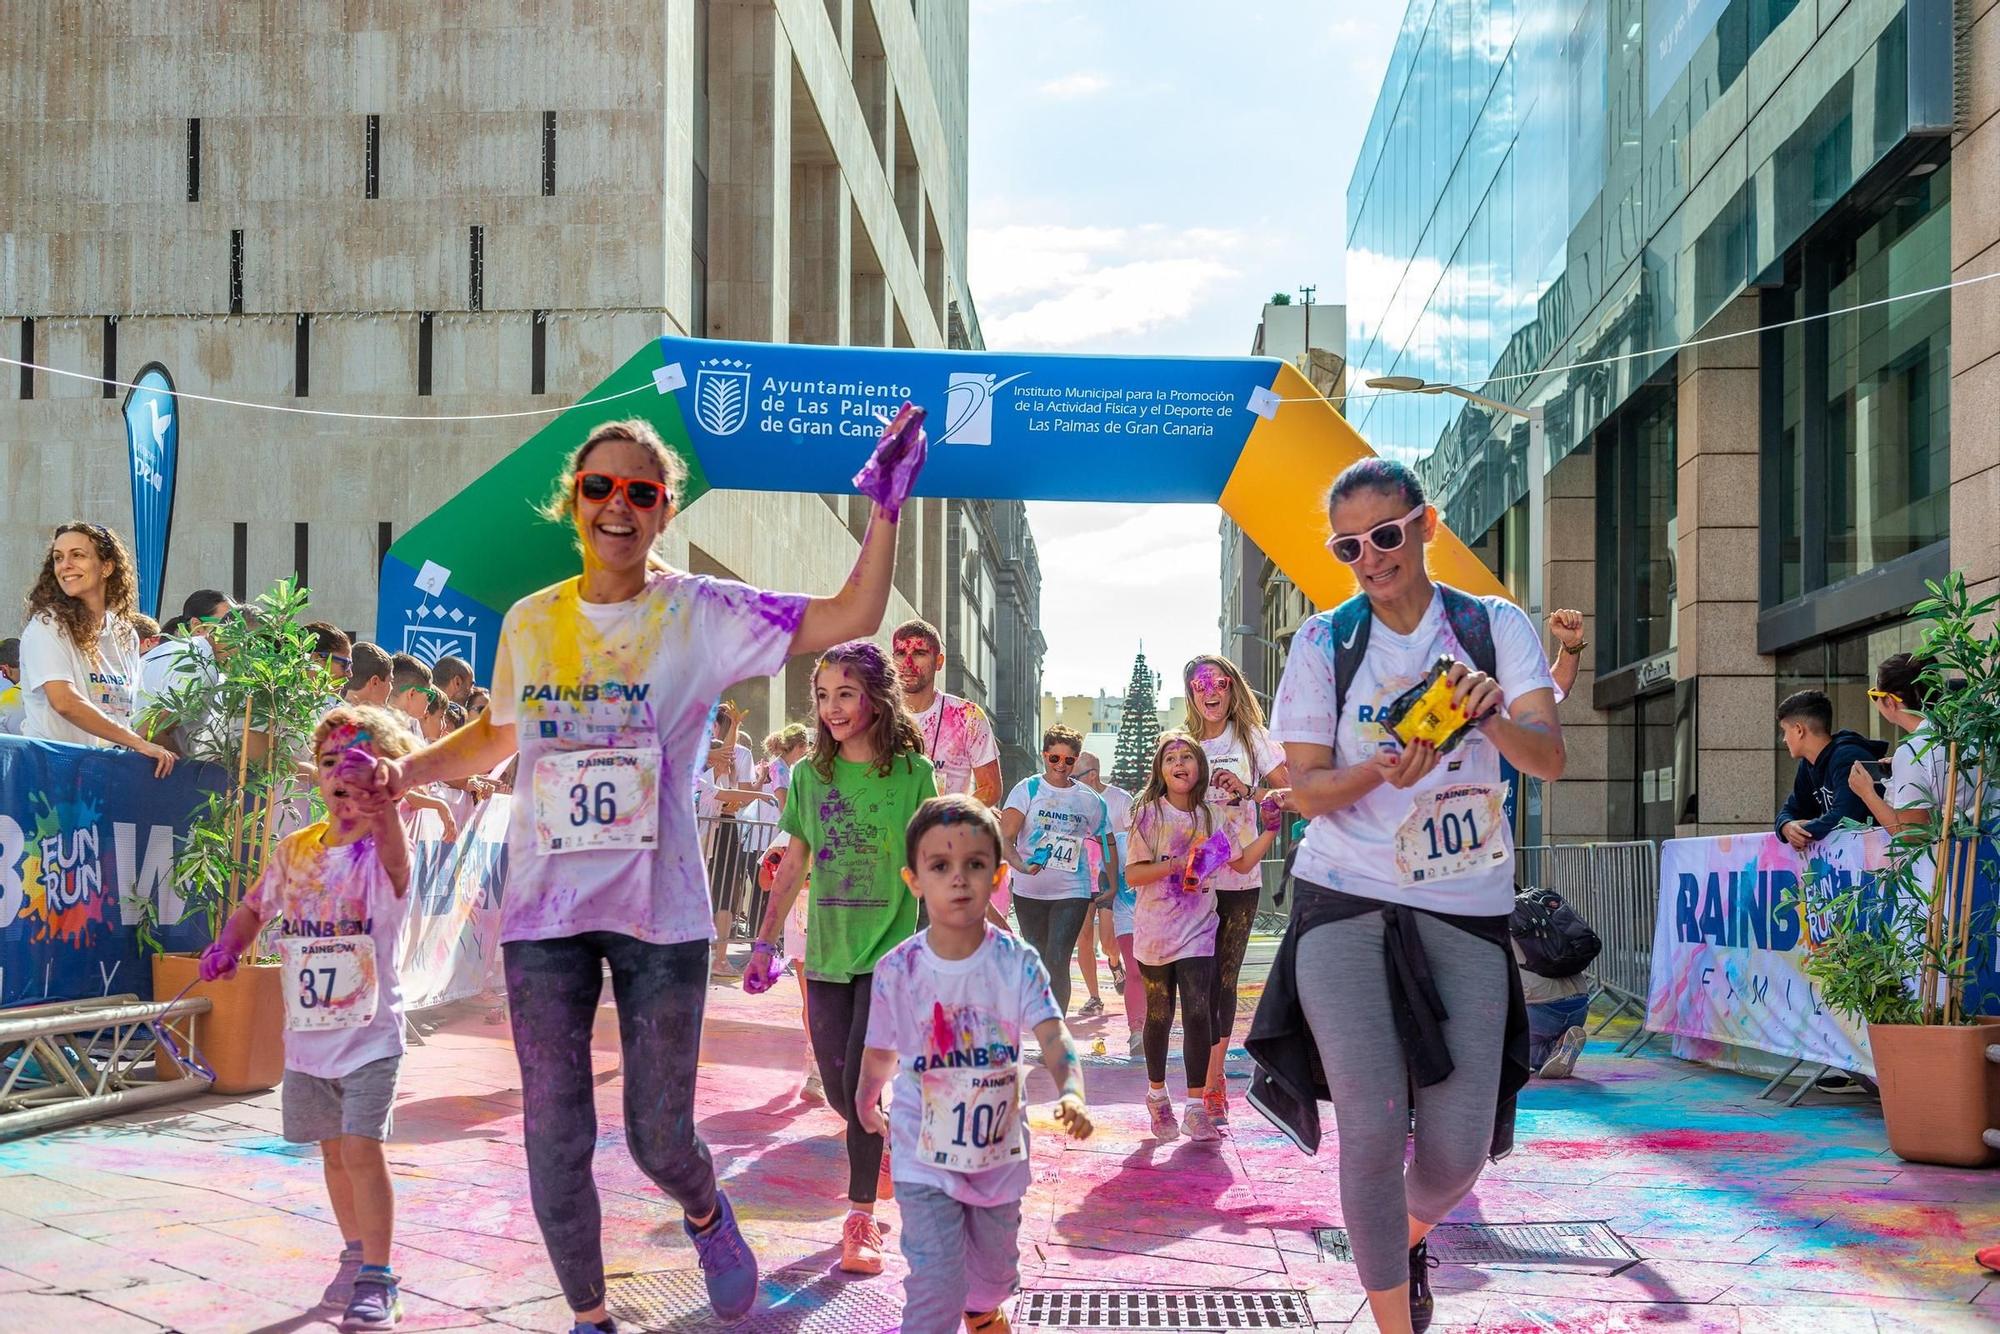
[970,226,1240,350]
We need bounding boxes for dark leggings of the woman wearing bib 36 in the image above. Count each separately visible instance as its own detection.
[502,932,716,1310]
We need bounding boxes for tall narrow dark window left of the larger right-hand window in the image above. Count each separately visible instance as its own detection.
[1596,384,1678,674]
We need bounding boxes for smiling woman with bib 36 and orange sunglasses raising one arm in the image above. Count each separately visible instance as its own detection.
[364,420,914,1334]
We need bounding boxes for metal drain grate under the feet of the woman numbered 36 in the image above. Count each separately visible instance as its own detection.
[604,1266,902,1334]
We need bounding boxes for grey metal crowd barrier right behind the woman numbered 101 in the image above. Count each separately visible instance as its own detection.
[1514,838,1660,1056]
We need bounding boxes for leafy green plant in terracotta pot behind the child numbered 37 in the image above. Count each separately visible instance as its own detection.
[136,580,336,1094]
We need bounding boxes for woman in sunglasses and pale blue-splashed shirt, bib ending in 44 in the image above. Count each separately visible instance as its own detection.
[1000,722,1118,1014]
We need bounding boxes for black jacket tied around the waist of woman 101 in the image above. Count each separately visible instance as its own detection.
[1244,880,1530,1158]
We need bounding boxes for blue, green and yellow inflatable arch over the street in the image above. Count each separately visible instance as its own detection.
[376,336,1506,680]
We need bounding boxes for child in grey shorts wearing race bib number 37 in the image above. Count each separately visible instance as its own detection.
[202,704,416,1330]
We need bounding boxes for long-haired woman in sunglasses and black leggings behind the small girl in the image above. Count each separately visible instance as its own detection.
[1180,654,1290,1126]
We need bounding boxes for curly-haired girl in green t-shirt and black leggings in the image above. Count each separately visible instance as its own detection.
[744,640,938,1274]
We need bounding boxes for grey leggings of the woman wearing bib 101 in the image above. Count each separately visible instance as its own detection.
[1296,912,1514,1292]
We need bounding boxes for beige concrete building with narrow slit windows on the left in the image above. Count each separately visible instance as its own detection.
[0,0,1038,740]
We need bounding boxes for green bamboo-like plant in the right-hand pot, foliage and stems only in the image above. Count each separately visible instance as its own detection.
[1800,572,2000,1024]
